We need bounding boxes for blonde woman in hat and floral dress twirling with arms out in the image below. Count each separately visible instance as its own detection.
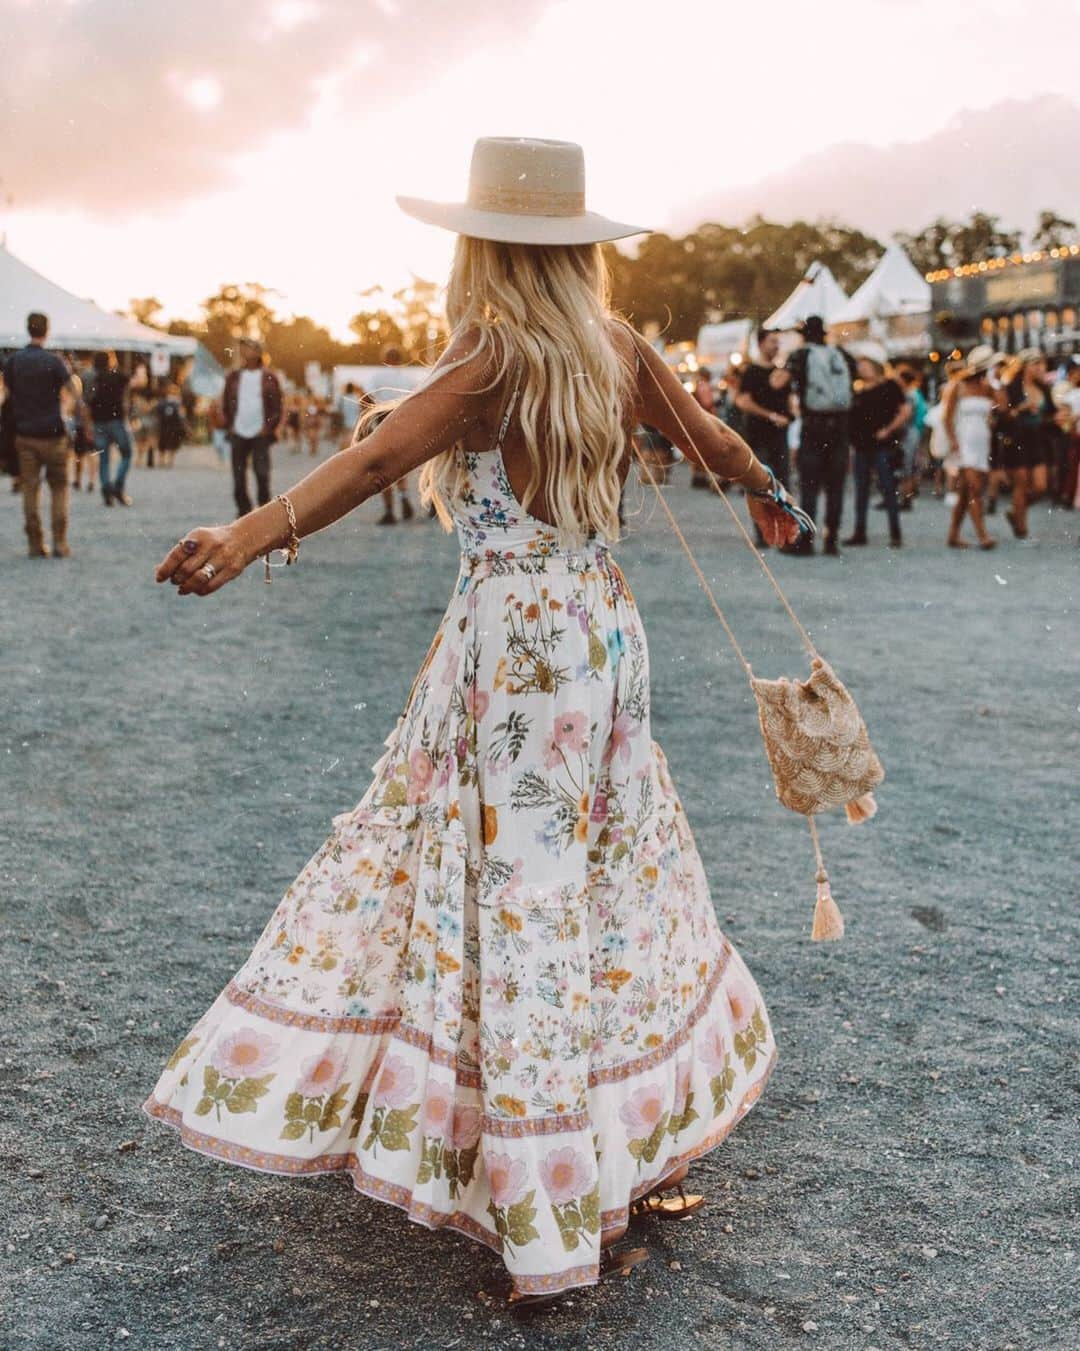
[146,141,799,1298]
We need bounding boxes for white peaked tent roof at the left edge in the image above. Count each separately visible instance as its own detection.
[0,245,197,357]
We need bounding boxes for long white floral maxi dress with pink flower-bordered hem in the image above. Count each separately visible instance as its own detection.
[146,413,775,1293]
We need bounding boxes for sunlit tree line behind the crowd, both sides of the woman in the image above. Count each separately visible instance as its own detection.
[128,211,1077,384]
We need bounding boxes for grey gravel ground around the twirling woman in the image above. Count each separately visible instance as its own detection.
[0,453,1080,1351]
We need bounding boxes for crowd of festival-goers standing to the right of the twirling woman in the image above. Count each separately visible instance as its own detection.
[659,316,1080,557]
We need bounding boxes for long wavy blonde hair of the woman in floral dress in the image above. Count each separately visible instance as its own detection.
[361,235,634,543]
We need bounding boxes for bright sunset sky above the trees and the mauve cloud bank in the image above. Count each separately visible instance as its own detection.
[0,0,1080,335]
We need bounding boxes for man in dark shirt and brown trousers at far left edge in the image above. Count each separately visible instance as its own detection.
[4,313,80,558]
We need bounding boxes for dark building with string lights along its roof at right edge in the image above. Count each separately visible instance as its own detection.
[926,245,1080,357]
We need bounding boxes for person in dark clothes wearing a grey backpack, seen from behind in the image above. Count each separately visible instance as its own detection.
[788,315,856,555]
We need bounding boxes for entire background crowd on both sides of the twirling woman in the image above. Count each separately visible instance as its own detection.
[0,305,1080,557]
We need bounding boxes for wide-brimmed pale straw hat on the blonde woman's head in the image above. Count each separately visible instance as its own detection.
[397,136,649,245]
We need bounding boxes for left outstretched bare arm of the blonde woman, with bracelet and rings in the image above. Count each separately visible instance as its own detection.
[155,339,495,596]
